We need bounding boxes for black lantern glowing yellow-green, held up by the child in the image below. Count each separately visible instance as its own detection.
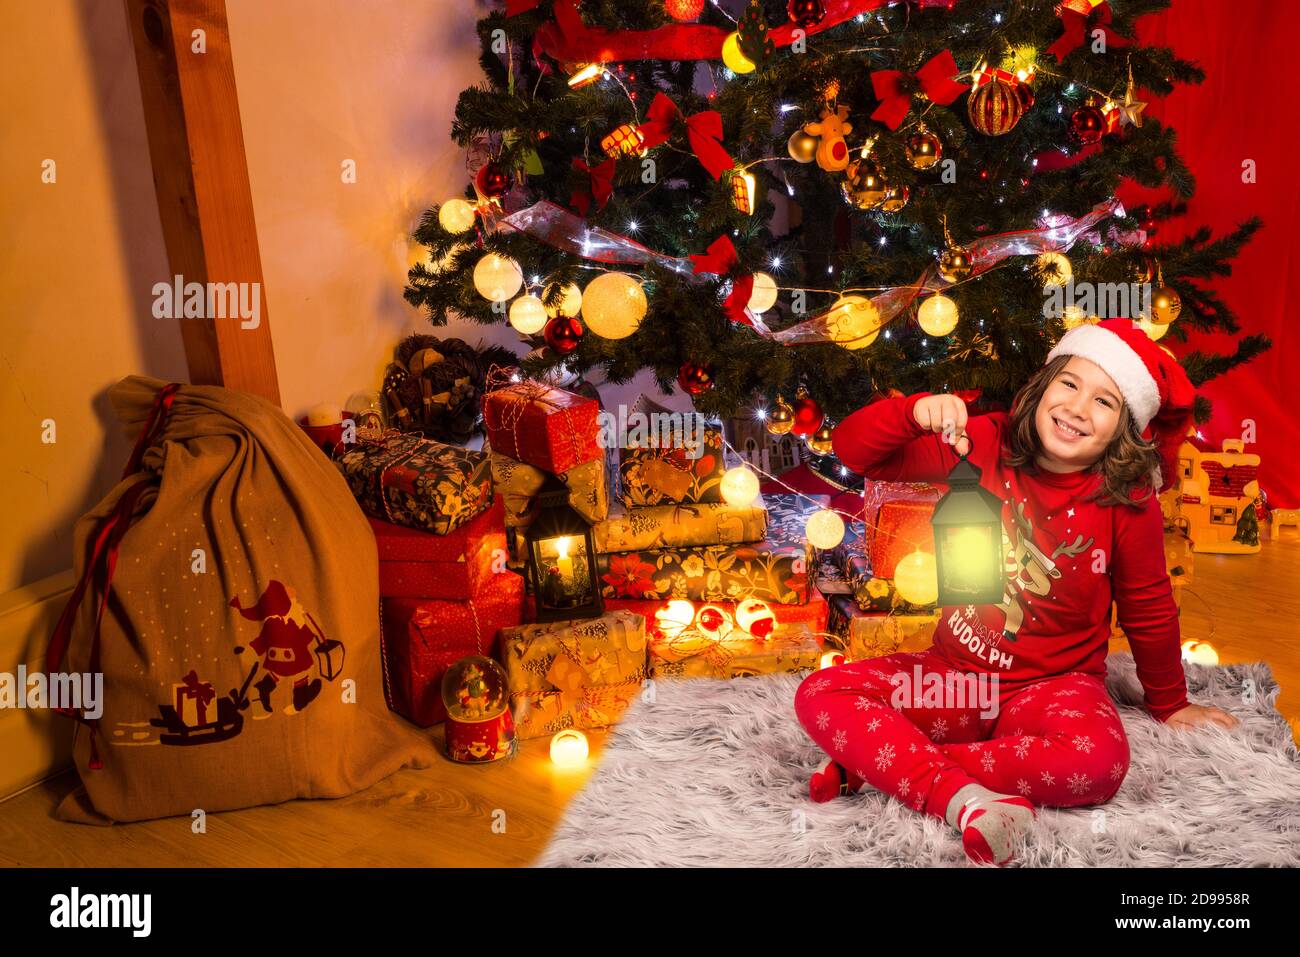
[932,436,1005,606]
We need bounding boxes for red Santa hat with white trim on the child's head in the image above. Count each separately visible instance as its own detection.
[1047,319,1196,494]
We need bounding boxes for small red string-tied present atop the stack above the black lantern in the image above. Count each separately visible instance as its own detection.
[484,380,605,475]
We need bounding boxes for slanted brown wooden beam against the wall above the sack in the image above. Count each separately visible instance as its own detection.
[125,0,280,406]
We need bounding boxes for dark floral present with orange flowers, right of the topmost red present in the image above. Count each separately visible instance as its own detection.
[619,428,727,507]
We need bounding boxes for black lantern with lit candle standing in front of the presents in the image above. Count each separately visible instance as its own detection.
[527,477,605,622]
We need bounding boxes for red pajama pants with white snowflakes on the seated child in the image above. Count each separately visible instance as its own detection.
[794,650,1128,819]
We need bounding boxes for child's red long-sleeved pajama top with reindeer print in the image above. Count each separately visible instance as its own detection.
[833,393,1187,722]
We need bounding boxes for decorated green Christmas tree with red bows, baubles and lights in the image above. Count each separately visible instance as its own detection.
[406,0,1270,442]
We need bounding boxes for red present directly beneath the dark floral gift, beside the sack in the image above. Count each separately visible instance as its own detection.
[371,498,508,598]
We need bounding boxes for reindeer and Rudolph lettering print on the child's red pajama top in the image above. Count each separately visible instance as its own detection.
[948,482,1095,671]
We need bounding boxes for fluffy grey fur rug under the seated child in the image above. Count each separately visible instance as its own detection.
[534,654,1300,867]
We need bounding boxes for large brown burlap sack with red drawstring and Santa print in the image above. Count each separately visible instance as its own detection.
[47,376,436,823]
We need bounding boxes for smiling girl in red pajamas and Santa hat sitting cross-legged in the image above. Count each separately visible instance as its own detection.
[794,320,1236,865]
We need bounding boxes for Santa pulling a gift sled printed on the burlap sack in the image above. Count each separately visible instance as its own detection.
[150,580,345,745]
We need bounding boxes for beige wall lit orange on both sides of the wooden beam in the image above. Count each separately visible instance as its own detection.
[0,0,684,593]
